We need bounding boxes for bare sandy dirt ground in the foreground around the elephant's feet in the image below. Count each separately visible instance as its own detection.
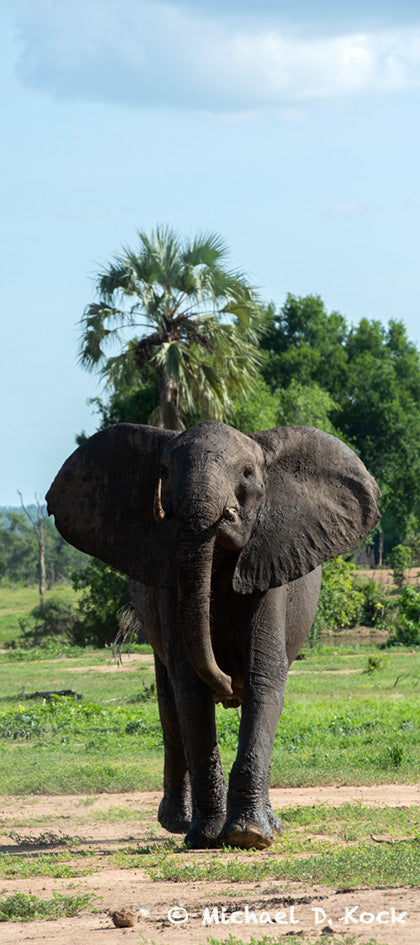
[0,784,420,945]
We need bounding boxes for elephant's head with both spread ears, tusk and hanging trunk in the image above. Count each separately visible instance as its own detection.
[46,421,380,700]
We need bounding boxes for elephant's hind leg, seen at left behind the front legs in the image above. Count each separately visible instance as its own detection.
[155,654,192,833]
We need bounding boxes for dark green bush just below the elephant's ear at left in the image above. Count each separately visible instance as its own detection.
[72,558,130,647]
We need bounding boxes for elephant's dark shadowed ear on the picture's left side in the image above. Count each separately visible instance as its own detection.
[45,423,176,587]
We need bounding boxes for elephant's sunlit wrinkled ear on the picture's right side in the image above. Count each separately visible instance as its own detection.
[233,427,381,594]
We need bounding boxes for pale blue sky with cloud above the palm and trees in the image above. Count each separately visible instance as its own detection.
[0,0,420,505]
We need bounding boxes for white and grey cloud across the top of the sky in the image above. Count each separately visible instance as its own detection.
[9,0,420,111]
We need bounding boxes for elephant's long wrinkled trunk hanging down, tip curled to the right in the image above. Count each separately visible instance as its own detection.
[177,530,233,699]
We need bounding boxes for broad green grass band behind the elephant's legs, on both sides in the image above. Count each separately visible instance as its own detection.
[0,647,420,795]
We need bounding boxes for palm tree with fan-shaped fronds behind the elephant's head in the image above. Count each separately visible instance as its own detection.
[80,226,262,430]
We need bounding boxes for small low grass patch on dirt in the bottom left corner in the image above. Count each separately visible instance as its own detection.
[0,893,98,922]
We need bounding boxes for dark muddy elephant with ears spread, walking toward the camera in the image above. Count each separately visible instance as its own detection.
[46,420,380,849]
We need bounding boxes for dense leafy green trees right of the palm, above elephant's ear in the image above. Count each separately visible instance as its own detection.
[261,295,420,553]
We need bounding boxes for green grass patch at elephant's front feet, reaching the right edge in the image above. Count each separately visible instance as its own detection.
[112,804,420,888]
